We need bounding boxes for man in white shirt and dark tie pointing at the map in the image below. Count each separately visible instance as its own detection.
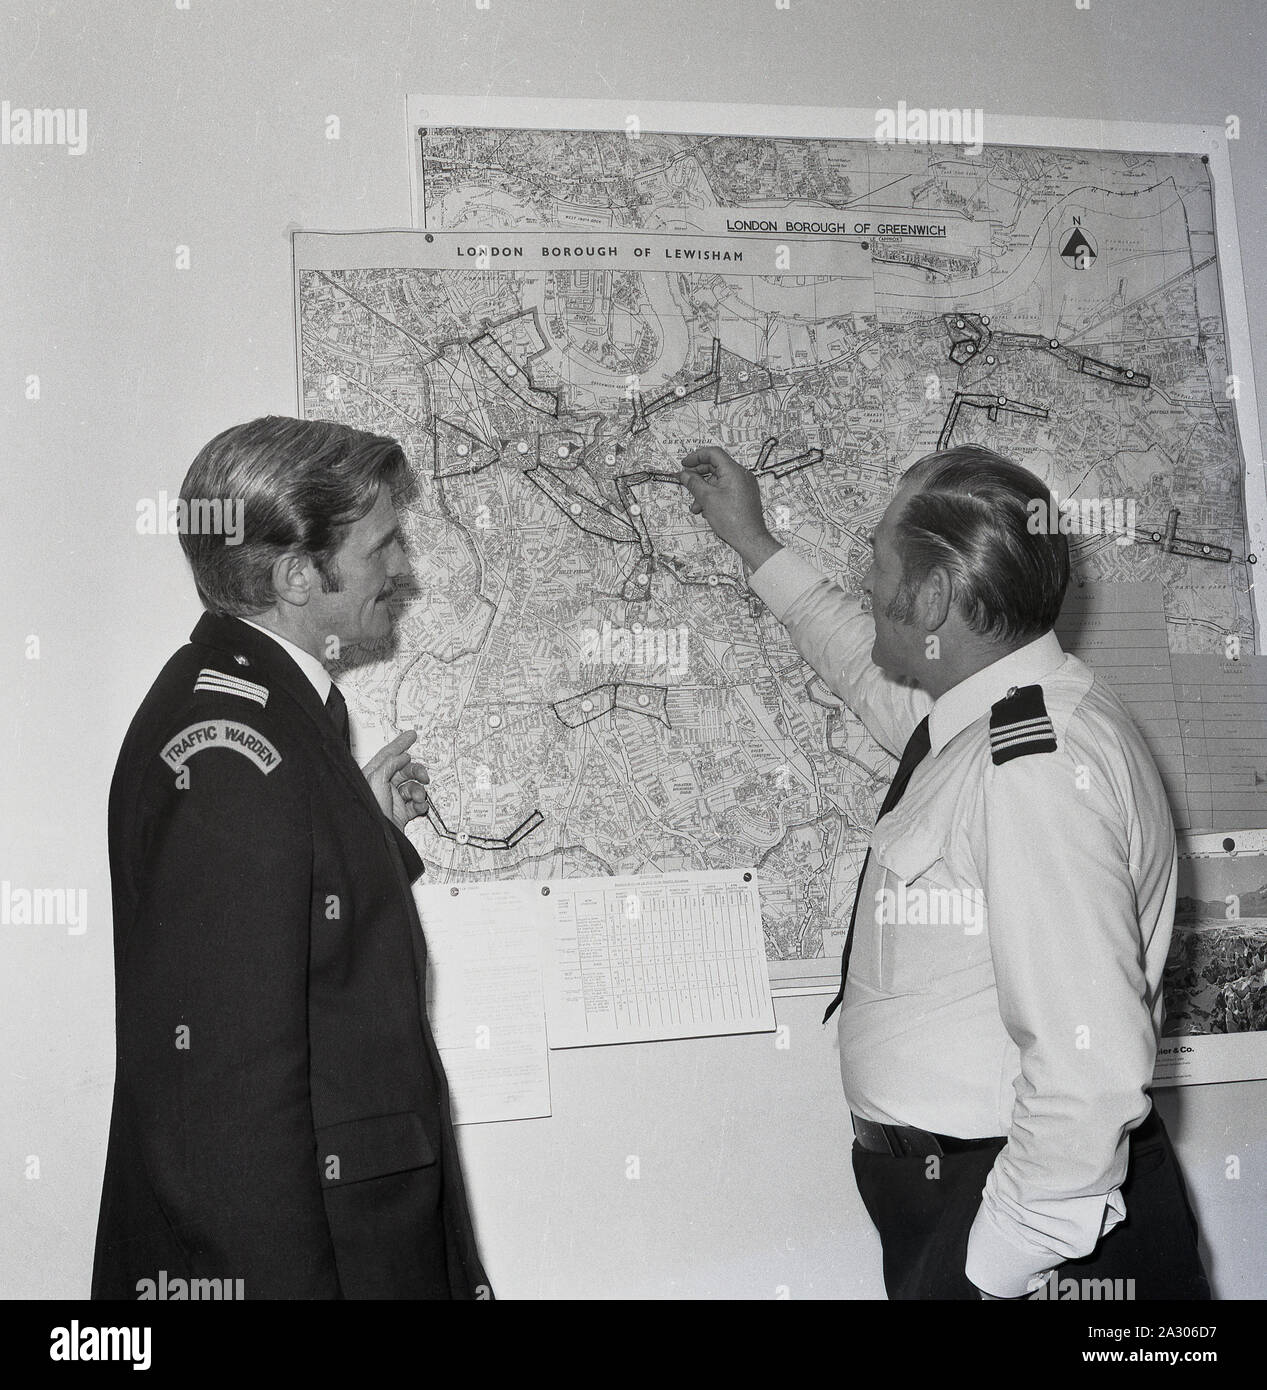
[681,445,1210,1298]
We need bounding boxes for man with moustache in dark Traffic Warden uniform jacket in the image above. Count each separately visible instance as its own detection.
[92,417,492,1298]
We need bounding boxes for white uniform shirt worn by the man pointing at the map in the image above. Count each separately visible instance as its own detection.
[749,549,1177,1297]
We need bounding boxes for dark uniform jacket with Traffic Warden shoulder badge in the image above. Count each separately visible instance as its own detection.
[92,614,490,1298]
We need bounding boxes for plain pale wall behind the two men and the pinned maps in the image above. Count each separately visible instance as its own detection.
[0,0,1267,1297]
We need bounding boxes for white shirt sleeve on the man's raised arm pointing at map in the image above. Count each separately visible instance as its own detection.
[747,546,932,758]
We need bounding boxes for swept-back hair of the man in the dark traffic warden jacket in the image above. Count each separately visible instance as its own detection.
[181,416,408,617]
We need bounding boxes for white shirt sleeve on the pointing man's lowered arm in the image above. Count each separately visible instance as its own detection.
[966,749,1156,1298]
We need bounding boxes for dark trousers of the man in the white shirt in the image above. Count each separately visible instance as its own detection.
[853,1111,1210,1301]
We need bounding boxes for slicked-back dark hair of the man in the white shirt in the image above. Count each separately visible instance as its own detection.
[889,443,1070,642]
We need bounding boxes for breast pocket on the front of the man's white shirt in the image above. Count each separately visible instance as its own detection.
[875,833,985,994]
